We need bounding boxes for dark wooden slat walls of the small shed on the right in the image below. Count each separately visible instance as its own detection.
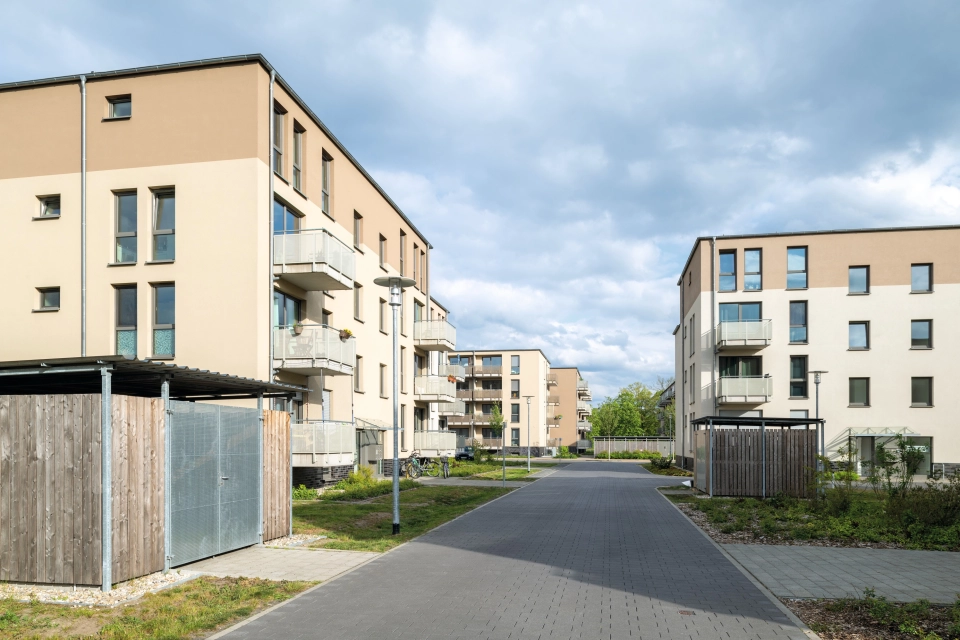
[693,429,817,497]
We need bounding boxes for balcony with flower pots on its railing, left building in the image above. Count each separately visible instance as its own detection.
[273,324,357,376]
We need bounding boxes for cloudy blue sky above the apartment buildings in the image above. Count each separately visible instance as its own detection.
[0,0,960,400]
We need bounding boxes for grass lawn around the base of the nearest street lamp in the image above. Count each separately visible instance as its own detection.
[293,486,510,552]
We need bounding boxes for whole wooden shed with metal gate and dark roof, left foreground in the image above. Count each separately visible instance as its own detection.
[0,356,305,590]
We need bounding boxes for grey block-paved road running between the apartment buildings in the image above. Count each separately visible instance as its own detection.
[221,462,806,640]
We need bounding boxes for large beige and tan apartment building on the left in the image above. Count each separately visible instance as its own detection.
[0,55,456,484]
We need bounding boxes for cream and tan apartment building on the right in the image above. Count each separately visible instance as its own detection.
[674,227,960,472]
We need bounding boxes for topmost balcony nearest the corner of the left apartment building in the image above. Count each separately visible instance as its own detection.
[273,229,357,291]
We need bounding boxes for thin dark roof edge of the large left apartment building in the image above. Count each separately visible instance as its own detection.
[0,53,433,249]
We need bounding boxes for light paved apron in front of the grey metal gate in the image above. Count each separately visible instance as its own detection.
[180,547,380,581]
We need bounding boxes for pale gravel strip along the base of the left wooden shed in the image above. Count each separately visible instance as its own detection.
[0,569,200,607]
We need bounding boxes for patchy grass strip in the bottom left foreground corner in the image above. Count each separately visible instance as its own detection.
[0,576,314,640]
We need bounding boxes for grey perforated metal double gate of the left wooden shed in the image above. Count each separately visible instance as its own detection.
[170,401,261,566]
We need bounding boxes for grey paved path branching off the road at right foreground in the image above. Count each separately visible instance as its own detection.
[723,544,960,604]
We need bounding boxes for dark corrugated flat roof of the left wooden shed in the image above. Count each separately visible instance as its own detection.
[0,356,307,400]
